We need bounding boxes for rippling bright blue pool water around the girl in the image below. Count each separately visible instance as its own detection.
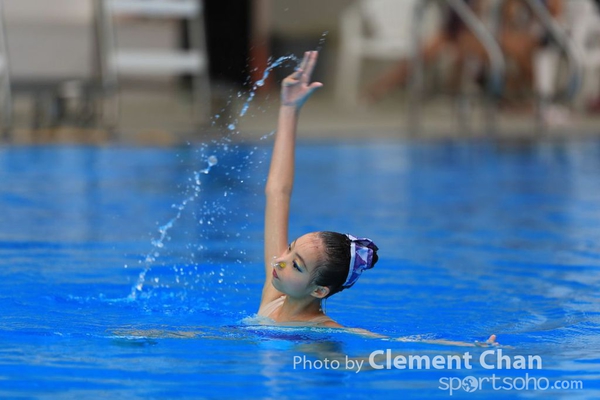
[0,140,600,399]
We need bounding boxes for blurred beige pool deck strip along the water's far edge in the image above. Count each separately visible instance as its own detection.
[7,86,600,146]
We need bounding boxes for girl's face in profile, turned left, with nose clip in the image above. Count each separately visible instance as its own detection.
[272,233,325,298]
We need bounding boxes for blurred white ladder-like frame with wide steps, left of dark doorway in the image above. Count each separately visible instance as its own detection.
[95,0,211,130]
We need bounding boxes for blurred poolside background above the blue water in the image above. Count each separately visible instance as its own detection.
[0,0,600,145]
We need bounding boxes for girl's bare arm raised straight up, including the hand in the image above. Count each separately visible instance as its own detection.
[261,51,323,306]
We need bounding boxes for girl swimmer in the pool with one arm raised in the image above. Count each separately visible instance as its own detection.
[258,51,496,346]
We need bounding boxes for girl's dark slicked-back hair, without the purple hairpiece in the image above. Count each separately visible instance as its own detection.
[313,231,379,298]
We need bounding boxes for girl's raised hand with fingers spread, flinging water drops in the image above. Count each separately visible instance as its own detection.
[281,51,323,108]
